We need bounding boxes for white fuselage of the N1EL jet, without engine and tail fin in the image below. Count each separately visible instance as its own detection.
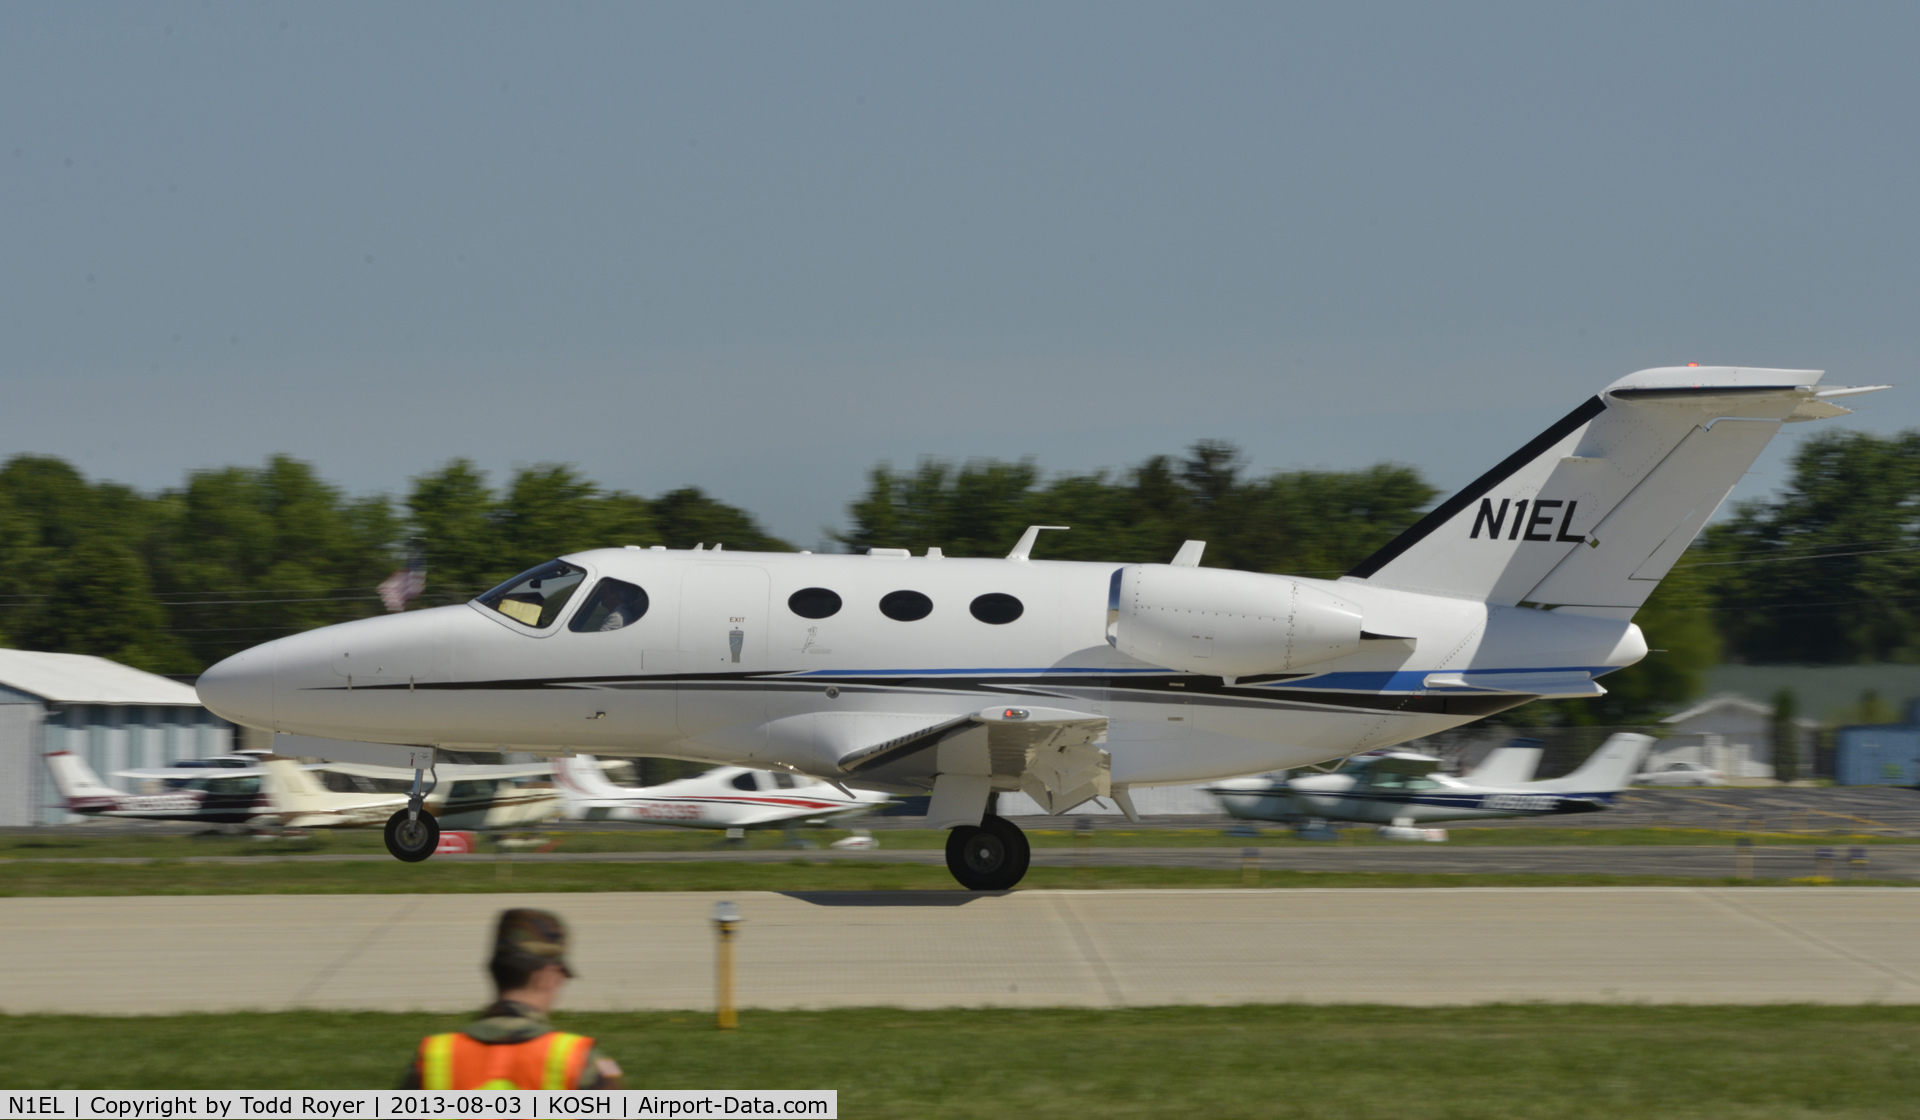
[200,548,1645,790]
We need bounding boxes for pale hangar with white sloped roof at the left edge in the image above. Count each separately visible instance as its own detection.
[0,649,234,826]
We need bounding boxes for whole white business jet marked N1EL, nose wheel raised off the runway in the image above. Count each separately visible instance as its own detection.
[200,367,1885,889]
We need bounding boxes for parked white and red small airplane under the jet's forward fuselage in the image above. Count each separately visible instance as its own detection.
[553,755,893,828]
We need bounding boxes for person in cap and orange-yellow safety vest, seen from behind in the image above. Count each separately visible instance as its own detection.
[399,909,624,1089]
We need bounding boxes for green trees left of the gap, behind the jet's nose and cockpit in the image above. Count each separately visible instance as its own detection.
[0,455,789,672]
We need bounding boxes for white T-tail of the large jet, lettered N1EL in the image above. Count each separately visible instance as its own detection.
[1346,365,1885,619]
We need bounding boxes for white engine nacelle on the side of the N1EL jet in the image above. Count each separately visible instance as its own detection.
[1106,565,1359,676]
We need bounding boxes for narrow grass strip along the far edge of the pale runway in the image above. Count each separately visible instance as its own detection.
[0,859,1896,897]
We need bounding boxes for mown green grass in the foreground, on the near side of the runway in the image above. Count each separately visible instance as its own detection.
[0,1005,1920,1120]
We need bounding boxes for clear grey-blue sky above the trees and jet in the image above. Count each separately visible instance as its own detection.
[0,2,1920,544]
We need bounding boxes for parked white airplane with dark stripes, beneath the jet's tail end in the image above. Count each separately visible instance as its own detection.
[1208,732,1653,828]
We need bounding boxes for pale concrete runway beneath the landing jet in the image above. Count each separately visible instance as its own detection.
[0,888,1920,1012]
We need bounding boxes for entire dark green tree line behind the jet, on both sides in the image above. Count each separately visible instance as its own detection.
[0,432,1920,722]
